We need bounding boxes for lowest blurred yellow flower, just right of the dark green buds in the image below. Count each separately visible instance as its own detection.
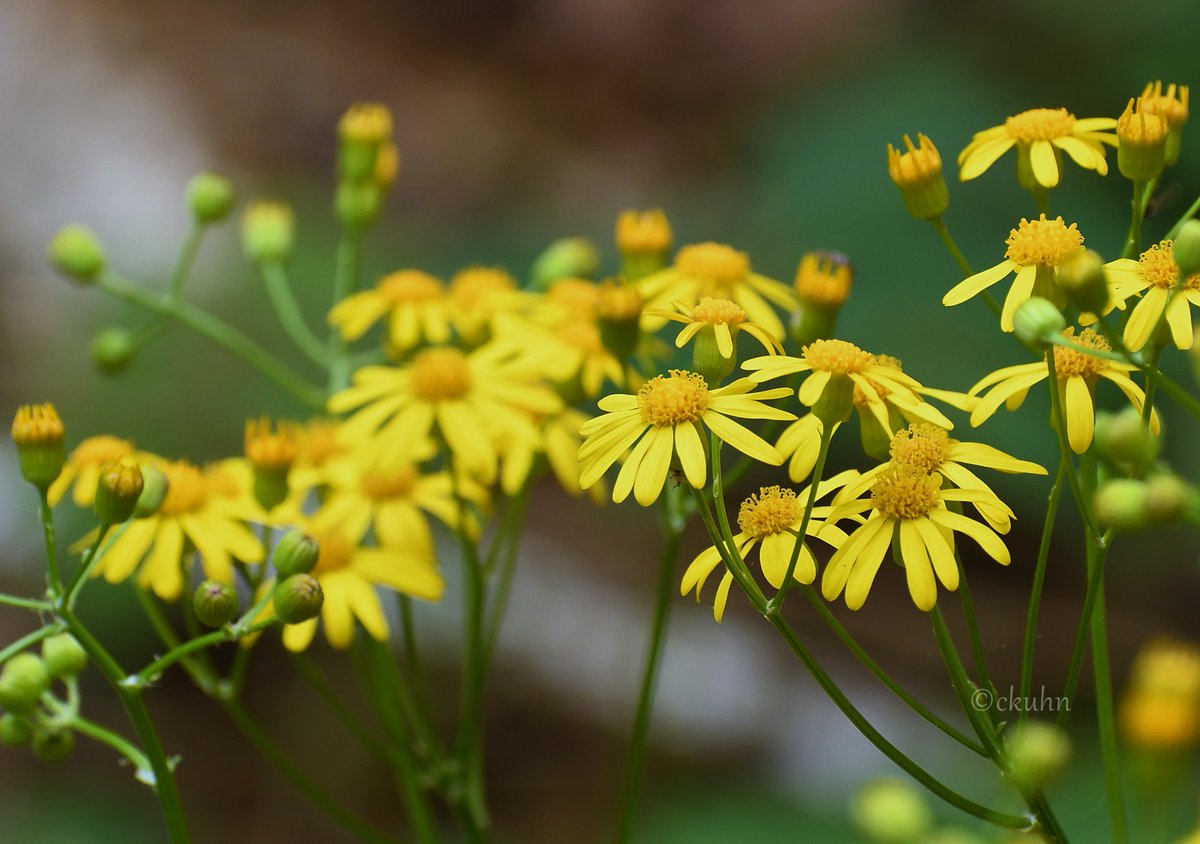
[274,531,445,653]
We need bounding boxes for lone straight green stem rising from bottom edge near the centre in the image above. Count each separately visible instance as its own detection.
[617,499,685,843]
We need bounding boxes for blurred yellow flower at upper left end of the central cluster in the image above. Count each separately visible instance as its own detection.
[329,270,450,352]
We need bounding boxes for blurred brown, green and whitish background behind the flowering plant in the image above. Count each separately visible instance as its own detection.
[0,0,1200,844]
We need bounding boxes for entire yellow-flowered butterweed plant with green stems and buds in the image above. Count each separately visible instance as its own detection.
[7,83,1200,843]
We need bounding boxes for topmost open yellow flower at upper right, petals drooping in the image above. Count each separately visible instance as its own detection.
[959,108,1117,187]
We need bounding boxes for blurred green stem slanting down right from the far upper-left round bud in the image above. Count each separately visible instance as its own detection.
[96,273,325,411]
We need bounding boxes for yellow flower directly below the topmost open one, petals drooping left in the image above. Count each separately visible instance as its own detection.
[942,214,1084,331]
